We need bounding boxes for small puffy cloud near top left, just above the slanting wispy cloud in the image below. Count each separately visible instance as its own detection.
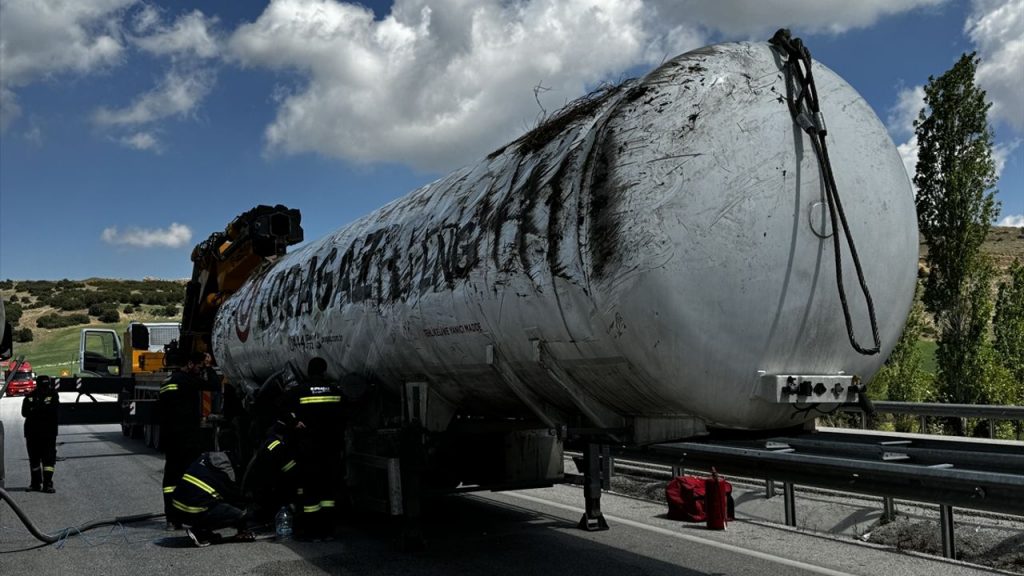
[132,7,220,58]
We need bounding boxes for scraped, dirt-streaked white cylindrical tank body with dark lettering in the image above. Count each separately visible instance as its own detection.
[213,43,918,428]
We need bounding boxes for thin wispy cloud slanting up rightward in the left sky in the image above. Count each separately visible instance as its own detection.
[92,69,216,126]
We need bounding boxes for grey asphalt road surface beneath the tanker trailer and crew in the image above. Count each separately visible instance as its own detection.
[0,399,1007,576]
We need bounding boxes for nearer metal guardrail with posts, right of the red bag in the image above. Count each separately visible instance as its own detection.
[613,433,1024,558]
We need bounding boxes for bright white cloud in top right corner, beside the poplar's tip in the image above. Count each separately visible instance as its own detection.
[964,0,1024,133]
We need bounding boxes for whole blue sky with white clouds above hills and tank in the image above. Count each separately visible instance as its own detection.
[0,0,1024,279]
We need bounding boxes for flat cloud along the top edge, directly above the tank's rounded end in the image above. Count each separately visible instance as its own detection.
[648,0,946,40]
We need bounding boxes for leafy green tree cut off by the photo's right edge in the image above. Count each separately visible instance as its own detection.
[992,258,1024,403]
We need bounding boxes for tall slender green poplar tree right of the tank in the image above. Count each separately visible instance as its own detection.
[913,53,998,434]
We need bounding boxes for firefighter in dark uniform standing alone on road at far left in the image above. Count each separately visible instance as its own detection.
[22,375,60,493]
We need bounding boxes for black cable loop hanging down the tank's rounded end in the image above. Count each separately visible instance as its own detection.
[768,28,882,356]
